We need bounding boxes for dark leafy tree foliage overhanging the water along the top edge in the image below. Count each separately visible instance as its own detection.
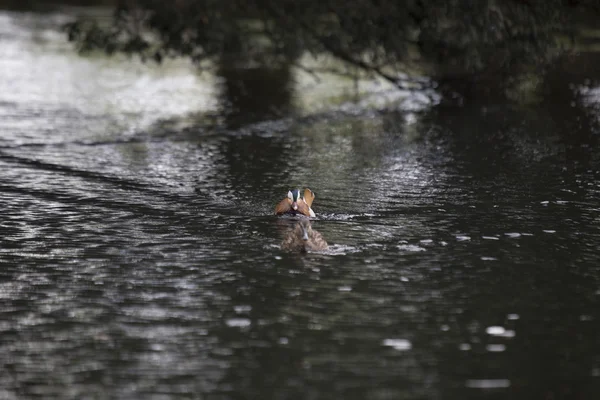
[67,0,599,92]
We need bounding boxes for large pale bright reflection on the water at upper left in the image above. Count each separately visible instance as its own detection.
[0,8,217,145]
